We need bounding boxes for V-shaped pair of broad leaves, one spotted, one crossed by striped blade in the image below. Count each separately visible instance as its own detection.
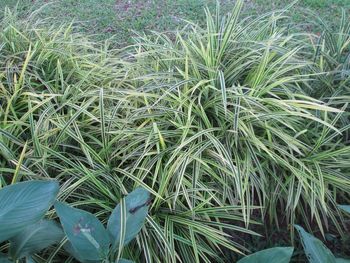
[55,187,150,262]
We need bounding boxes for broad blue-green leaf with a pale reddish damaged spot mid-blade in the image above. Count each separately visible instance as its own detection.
[55,202,110,260]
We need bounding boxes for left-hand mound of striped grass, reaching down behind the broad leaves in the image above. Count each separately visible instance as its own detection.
[0,4,262,262]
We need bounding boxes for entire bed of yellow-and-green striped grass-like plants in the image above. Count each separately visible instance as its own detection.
[0,2,350,262]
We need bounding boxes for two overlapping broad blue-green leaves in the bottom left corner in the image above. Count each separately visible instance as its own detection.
[0,180,60,262]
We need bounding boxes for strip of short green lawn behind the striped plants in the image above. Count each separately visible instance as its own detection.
[0,0,350,46]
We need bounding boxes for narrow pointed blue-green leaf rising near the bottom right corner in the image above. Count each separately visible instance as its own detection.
[295,225,336,263]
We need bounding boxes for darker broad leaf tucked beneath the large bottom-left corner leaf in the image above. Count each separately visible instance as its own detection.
[10,220,64,259]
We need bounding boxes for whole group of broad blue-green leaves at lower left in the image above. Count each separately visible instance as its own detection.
[0,180,151,263]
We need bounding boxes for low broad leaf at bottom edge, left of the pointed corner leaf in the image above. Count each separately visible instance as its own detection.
[238,247,294,263]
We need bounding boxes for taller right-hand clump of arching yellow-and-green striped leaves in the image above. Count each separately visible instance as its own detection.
[131,0,350,244]
